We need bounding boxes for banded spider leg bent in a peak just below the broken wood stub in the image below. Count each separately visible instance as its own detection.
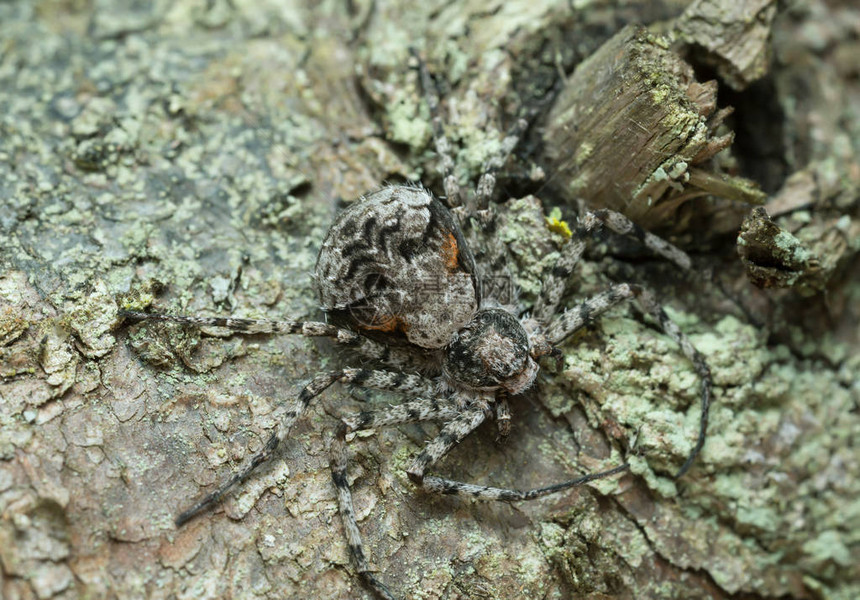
[534,209,692,321]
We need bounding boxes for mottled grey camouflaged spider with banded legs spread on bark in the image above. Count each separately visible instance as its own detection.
[121,55,711,600]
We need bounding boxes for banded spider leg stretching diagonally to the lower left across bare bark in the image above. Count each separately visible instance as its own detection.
[176,369,432,527]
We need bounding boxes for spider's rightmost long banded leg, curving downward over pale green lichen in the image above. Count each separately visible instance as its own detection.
[546,283,712,479]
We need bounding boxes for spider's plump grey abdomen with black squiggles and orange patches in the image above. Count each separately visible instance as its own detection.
[316,185,480,349]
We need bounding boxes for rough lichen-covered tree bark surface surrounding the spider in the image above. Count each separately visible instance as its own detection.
[0,0,860,600]
